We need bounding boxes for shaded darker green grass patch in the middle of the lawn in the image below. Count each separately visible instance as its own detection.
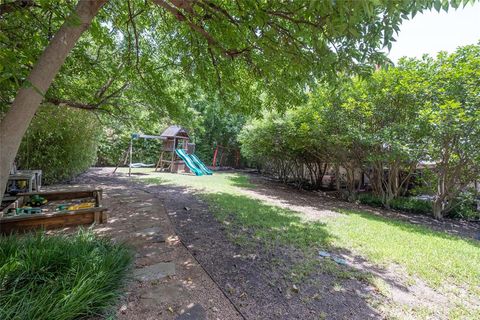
[201,193,371,283]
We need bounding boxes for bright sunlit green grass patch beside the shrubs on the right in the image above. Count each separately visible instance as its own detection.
[327,210,480,287]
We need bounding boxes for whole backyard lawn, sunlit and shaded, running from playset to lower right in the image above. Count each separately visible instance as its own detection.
[129,170,480,319]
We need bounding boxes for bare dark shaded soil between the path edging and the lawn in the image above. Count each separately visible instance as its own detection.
[148,186,381,319]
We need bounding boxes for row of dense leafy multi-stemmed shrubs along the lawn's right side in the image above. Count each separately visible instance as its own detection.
[240,43,480,217]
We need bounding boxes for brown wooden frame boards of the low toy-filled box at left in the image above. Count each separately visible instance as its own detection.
[0,189,107,233]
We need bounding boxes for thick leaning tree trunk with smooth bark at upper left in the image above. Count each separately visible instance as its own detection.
[0,0,108,201]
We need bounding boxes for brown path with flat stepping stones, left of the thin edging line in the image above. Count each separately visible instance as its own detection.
[63,174,242,320]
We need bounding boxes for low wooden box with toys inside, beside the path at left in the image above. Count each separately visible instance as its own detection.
[0,189,107,233]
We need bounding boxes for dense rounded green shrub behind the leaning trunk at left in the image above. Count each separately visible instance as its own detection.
[17,106,100,184]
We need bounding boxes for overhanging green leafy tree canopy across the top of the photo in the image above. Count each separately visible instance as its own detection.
[0,0,469,117]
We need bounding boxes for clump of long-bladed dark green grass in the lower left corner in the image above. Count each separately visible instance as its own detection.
[0,230,133,320]
